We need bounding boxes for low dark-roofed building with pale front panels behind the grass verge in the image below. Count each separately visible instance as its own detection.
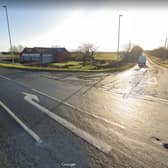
[20,47,70,64]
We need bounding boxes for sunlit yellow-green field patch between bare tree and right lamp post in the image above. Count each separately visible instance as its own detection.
[95,52,118,61]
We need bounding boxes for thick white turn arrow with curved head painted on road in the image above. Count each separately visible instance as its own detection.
[23,92,112,154]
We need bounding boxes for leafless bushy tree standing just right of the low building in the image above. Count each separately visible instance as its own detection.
[79,43,97,65]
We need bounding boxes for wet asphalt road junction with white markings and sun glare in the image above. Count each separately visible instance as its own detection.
[0,60,168,168]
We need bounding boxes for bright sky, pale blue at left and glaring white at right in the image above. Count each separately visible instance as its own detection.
[0,1,168,51]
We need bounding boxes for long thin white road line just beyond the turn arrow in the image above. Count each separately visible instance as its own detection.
[32,89,125,129]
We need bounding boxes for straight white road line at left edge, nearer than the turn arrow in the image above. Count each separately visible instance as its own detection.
[0,101,42,143]
